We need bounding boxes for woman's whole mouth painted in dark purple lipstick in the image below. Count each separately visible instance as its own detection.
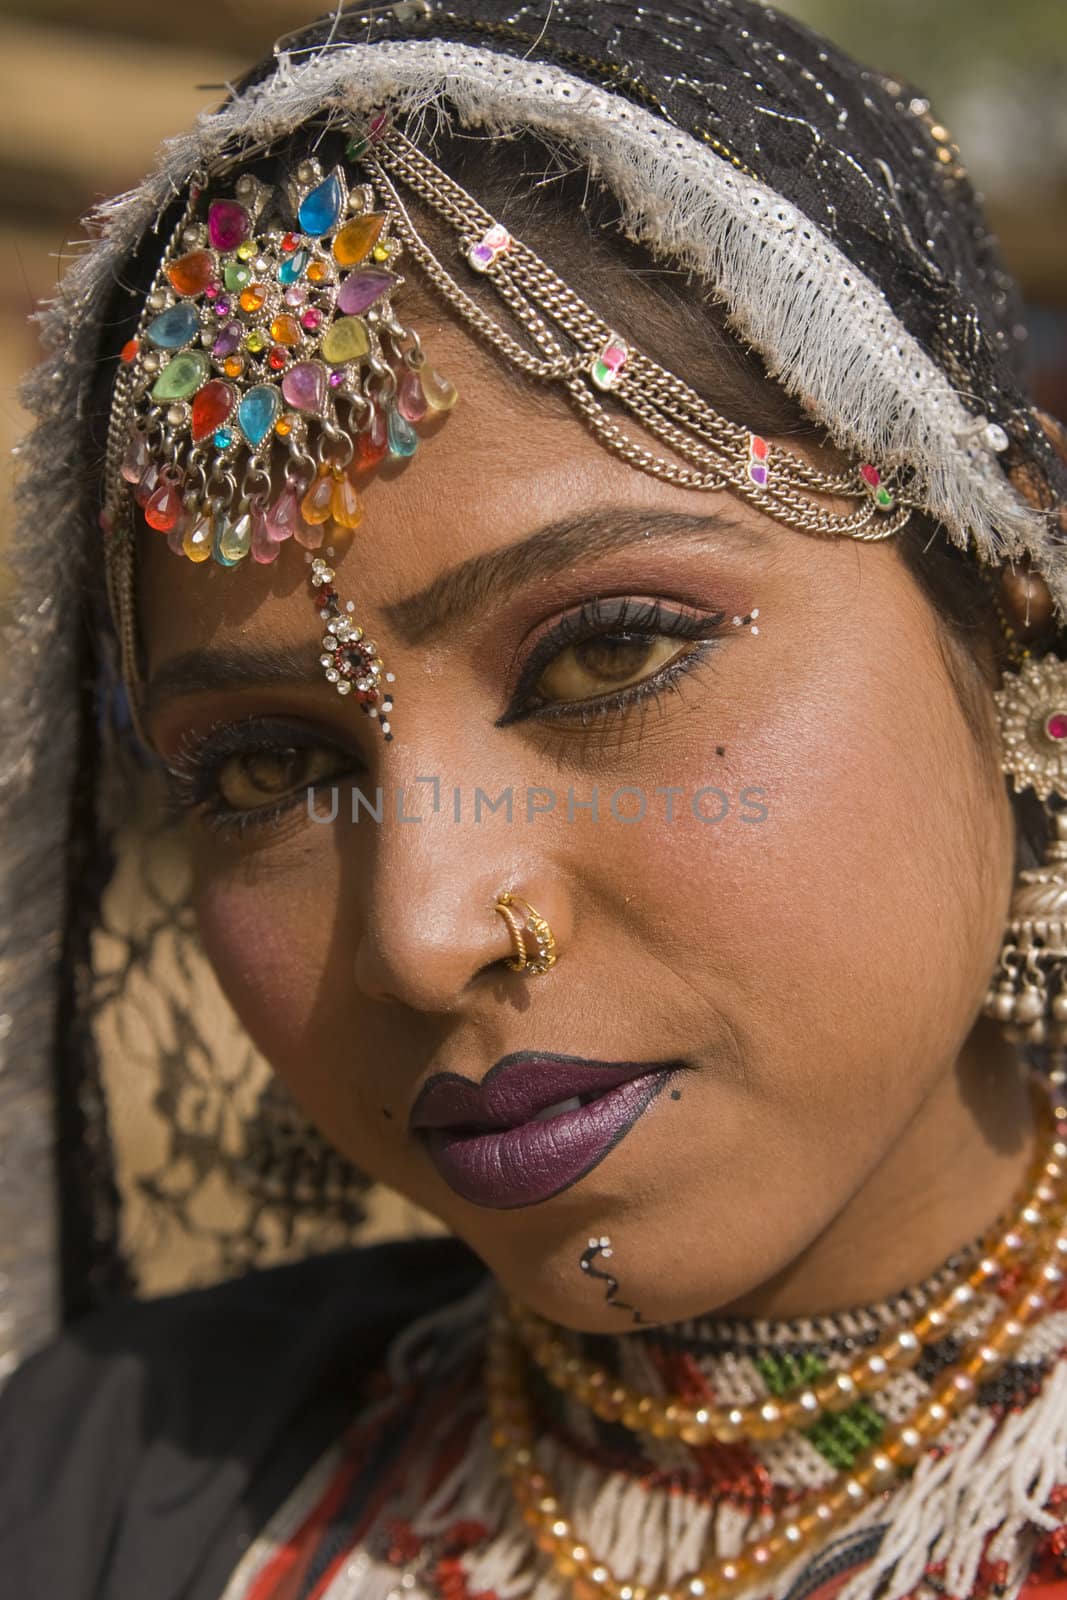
[408,1051,683,1210]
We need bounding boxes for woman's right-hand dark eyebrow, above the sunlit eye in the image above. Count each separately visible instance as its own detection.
[379,507,758,645]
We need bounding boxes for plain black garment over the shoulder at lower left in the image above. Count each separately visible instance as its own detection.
[0,1237,486,1600]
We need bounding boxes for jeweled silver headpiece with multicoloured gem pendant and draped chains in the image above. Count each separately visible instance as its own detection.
[101,110,972,739]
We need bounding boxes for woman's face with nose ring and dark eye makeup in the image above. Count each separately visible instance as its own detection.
[141,308,1019,1330]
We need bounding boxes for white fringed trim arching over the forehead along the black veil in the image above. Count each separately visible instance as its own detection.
[37,28,1067,616]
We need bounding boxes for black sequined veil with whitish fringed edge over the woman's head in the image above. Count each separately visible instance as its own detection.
[0,0,1067,1369]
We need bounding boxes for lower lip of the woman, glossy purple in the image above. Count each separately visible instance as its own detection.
[422,1067,675,1210]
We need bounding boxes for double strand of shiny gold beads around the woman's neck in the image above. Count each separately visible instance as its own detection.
[486,1068,1067,1600]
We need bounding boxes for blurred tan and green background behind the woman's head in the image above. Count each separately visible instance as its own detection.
[0,0,1067,521]
